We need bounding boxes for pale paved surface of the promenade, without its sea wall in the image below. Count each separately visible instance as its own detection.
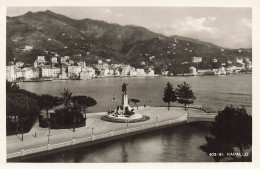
[7,106,202,154]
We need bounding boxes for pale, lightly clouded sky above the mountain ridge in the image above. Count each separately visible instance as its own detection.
[7,7,252,48]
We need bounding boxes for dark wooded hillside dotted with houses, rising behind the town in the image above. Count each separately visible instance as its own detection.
[7,11,252,66]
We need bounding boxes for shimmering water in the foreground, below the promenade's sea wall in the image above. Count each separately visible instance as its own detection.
[25,122,213,162]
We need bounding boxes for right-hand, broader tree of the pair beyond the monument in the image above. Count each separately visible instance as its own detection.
[175,82,196,110]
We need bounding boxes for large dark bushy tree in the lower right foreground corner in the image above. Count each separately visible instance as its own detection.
[201,106,252,161]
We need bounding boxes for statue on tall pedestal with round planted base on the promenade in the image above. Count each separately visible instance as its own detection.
[101,83,149,123]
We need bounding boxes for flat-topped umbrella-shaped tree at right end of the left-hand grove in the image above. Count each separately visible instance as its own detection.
[72,96,97,118]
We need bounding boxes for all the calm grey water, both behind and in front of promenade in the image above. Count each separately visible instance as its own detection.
[19,74,252,162]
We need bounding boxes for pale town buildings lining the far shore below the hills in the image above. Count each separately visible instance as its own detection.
[6,50,252,82]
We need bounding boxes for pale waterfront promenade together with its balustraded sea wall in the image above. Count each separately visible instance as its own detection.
[7,106,217,162]
